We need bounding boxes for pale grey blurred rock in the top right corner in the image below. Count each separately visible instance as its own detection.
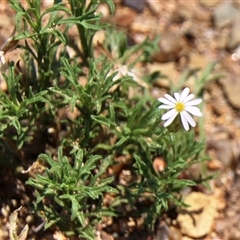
[213,1,239,28]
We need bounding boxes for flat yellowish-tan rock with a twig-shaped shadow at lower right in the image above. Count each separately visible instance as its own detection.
[177,192,218,239]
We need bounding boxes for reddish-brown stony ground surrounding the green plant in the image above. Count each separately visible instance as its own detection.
[0,0,240,240]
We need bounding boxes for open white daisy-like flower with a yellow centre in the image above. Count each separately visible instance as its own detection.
[158,88,202,131]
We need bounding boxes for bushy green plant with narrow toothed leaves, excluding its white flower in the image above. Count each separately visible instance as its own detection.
[0,0,211,239]
